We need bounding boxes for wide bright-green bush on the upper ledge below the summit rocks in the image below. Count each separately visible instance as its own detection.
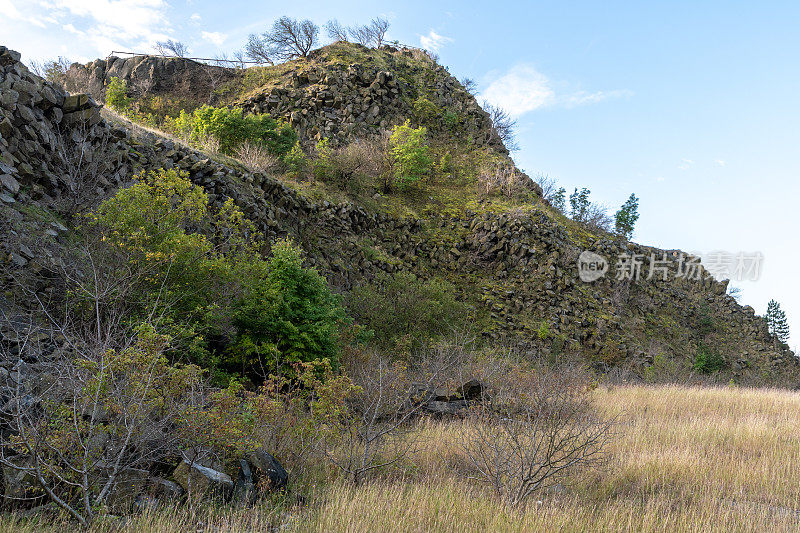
[173,105,298,156]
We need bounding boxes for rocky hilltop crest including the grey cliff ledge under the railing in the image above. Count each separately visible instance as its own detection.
[69,43,508,154]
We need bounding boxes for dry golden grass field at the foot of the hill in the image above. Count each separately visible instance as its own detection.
[6,386,800,532]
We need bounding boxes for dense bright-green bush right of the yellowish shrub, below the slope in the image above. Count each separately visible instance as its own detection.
[228,240,346,379]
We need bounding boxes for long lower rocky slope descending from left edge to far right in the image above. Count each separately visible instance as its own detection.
[0,43,797,380]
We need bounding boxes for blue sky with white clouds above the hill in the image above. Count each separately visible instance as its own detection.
[0,0,800,347]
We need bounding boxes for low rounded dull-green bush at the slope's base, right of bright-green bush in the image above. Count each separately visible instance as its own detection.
[346,272,467,354]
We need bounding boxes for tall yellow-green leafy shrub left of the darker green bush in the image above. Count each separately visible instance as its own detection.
[90,169,244,316]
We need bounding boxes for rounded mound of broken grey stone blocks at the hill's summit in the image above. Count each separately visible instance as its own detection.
[237,45,508,154]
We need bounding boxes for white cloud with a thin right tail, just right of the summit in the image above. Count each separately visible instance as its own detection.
[482,64,633,117]
